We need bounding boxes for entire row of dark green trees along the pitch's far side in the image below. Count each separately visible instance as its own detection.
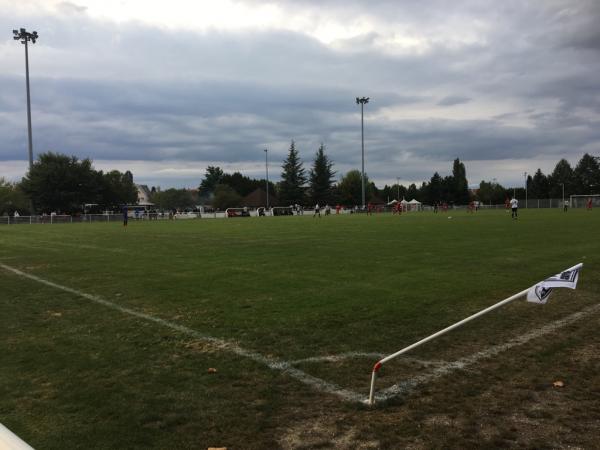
[0,146,600,215]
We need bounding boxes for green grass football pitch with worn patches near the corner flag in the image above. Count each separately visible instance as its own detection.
[0,209,600,449]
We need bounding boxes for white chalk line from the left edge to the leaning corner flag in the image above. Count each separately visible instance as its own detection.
[0,263,364,403]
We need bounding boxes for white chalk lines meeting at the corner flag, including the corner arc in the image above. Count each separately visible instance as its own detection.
[0,263,600,403]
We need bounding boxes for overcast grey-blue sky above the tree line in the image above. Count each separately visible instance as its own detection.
[0,0,600,188]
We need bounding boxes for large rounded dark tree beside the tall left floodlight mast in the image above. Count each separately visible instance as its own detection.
[21,152,103,213]
